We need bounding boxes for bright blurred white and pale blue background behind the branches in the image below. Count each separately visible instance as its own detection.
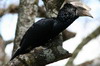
[0,0,100,66]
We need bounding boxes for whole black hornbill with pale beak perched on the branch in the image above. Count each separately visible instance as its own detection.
[11,2,92,60]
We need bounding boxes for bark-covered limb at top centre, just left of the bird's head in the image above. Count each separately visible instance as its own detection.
[43,0,64,17]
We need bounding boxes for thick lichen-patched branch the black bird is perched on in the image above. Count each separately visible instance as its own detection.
[6,35,71,66]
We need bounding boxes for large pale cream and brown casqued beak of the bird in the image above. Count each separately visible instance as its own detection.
[70,2,93,18]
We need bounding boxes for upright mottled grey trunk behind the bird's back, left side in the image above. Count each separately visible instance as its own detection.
[13,0,38,52]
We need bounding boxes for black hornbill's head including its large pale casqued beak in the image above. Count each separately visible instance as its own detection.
[57,2,93,20]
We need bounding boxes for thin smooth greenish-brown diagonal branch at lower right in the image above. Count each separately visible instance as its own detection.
[66,26,100,66]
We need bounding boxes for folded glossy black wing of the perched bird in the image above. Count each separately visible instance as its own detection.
[20,19,54,49]
